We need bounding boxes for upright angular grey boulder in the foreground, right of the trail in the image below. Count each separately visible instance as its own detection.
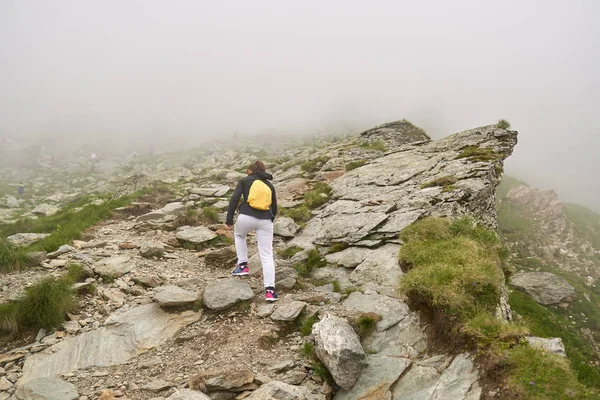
[312,314,367,390]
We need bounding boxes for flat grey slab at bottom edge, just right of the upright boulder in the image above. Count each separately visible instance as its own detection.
[335,354,411,400]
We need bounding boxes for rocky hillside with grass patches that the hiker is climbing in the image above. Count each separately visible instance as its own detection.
[0,120,597,400]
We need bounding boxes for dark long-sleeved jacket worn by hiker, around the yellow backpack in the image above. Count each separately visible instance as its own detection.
[225,171,277,225]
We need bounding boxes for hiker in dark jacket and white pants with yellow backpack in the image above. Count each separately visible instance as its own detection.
[226,161,279,302]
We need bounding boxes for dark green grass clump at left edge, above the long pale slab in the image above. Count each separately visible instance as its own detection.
[0,275,77,332]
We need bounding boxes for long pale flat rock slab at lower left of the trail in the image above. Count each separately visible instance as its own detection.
[19,304,200,383]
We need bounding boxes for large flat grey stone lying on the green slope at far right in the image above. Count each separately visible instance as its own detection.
[510,272,575,305]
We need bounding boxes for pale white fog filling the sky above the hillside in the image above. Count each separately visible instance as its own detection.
[0,0,600,210]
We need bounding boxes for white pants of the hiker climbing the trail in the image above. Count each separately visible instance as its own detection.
[233,214,275,287]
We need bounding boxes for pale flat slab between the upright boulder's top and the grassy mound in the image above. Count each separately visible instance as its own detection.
[343,292,410,331]
